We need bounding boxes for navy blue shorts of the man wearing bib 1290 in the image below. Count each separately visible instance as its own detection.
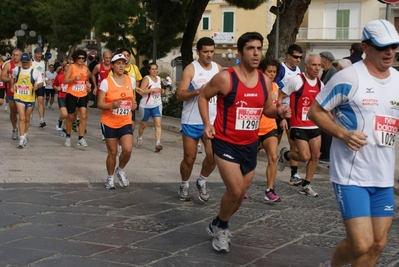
[212,138,259,175]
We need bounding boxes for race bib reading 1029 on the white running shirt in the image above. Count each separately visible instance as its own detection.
[374,115,399,148]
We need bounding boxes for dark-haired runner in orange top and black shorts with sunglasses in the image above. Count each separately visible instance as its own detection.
[64,49,91,147]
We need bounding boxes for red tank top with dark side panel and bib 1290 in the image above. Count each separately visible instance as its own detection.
[214,68,268,145]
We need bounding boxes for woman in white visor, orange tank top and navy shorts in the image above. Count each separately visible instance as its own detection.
[97,54,137,189]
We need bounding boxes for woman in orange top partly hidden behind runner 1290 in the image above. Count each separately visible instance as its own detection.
[258,59,281,202]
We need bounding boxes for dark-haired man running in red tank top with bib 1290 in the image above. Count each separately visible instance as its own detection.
[198,32,291,252]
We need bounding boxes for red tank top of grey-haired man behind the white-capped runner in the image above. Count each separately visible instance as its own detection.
[290,73,321,128]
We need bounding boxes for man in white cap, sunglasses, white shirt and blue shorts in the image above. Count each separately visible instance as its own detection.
[308,20,399,267]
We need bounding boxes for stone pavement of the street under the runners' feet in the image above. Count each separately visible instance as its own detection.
[0,101,399,267]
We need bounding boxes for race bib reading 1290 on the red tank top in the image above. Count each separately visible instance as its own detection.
[236,108,263,131]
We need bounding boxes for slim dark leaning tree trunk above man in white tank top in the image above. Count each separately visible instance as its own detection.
[180,0,209,69]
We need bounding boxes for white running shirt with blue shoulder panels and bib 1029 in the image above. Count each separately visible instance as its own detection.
[316,61,399,187]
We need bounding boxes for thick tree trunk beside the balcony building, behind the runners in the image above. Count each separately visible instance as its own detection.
[266,0,311,59]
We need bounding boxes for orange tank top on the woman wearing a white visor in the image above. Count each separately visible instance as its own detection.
[101,75,135,128]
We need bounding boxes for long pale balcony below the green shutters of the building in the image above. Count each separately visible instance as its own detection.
[296,28,362,42]
